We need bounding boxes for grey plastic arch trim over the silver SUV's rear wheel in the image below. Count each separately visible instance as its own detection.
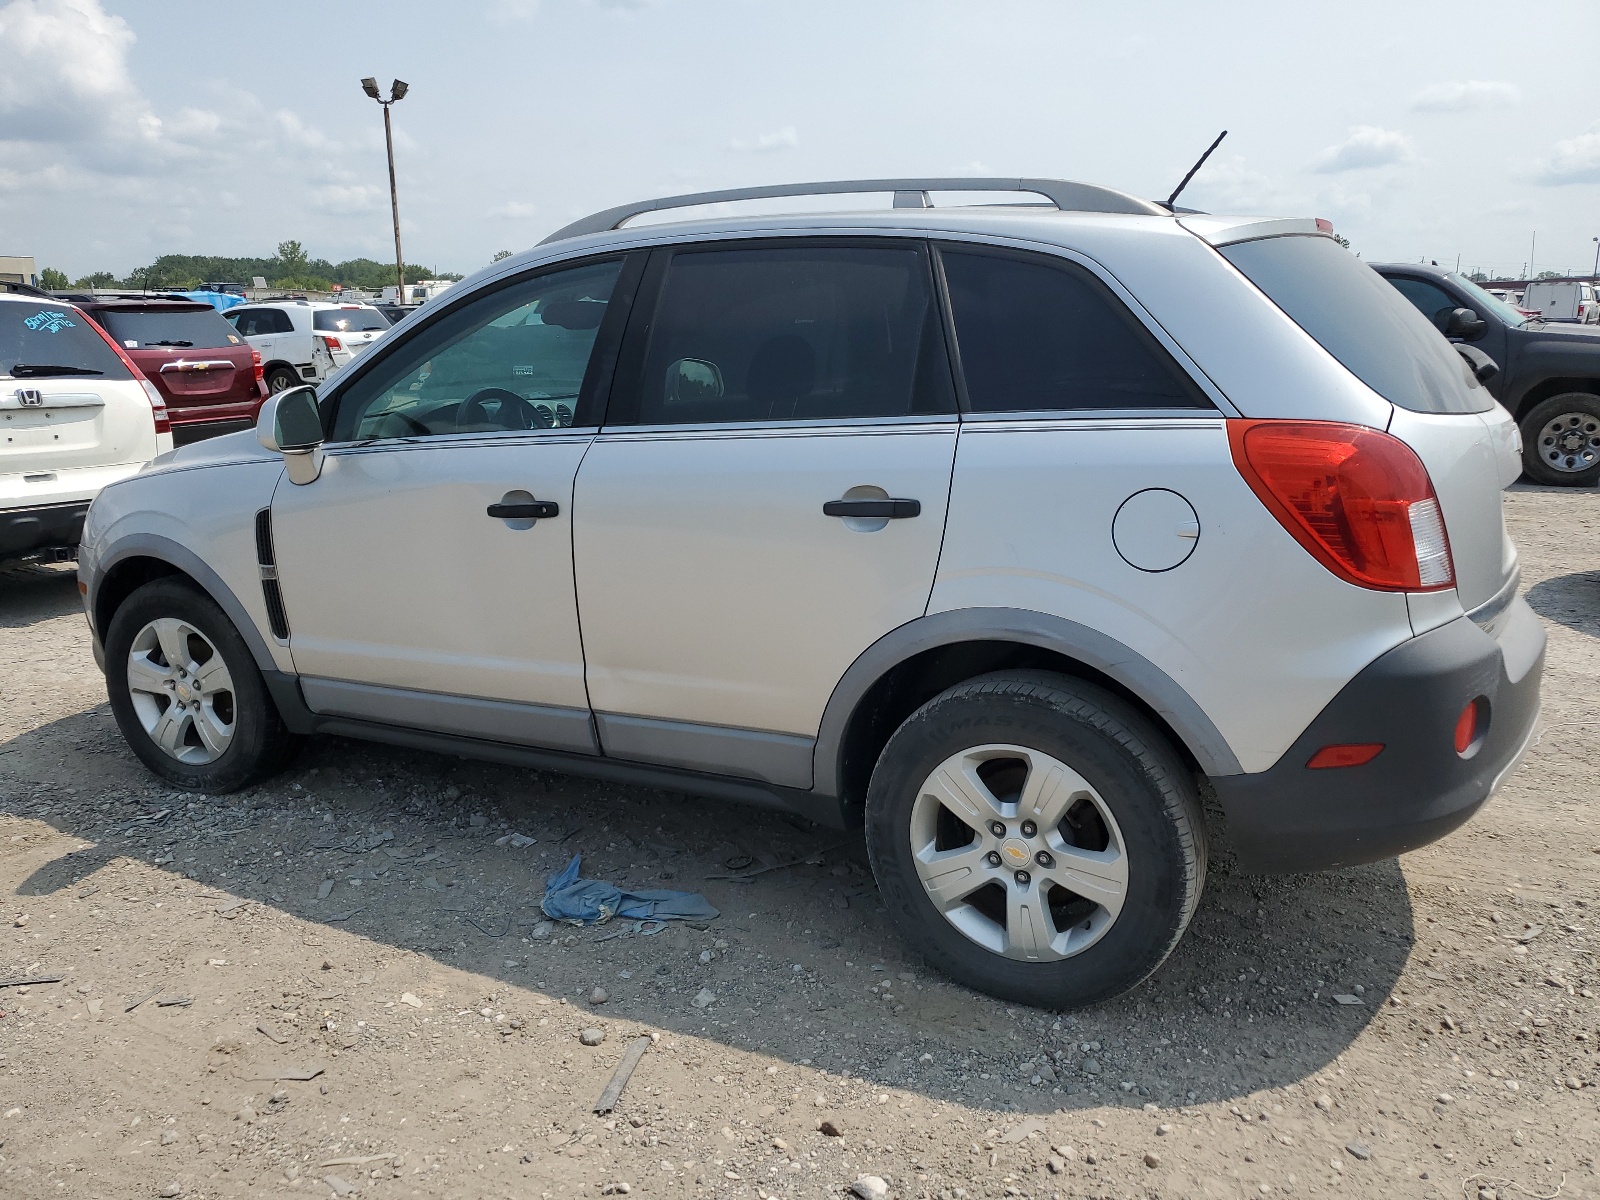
[814,608,1245,795]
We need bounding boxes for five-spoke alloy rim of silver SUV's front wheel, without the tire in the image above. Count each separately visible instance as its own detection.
[128,618,238,766]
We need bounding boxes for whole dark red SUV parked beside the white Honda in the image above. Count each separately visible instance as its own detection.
[78,296,267,446]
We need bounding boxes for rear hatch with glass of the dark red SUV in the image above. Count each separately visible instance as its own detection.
[94,301,259,421]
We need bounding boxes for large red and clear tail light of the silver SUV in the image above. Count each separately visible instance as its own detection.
[1227,421,1456,592]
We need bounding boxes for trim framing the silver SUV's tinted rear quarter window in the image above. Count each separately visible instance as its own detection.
[931,235,1242,422]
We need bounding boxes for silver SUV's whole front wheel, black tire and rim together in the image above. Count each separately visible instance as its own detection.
[106,578,298,794]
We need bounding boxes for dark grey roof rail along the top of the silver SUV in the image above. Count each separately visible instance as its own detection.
[539,178,1170,245]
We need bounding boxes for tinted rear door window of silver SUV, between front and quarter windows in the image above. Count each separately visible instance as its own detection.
[606,242,955,424]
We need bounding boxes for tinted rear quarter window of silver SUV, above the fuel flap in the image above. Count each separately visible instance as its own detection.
[939,246,1213,413]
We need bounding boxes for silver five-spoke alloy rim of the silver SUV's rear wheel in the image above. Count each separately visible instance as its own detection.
[910,744,1128,962]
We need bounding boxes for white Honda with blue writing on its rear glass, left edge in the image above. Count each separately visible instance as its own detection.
[0,290,173,562]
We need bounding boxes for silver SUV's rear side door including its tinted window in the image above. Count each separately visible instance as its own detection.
[573,238,957,787]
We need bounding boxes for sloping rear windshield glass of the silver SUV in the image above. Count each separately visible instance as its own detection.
[1221,235,1494,413]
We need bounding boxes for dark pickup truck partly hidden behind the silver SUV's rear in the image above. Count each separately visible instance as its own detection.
[1373,262,1600,488]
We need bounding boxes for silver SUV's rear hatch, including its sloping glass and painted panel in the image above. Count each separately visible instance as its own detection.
[1208,229,1520,611]
